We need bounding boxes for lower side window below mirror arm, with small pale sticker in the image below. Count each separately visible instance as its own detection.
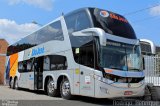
[70,36,95,68]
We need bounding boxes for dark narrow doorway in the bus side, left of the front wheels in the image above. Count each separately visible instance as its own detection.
[34,57,44,90]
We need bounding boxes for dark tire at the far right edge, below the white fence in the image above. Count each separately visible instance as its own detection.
[150,87,160,101]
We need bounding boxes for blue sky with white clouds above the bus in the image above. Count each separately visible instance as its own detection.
[0,0,160,45]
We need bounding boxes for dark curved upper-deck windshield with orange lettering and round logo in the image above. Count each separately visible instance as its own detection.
[89,8,136,39]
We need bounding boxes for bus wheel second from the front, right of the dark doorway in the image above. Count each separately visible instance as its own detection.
[47,79,59,97]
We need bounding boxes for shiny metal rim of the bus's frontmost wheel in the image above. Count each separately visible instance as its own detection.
[62,81,70,96]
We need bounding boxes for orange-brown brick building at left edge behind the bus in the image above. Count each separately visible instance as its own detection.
[0,39,8,84]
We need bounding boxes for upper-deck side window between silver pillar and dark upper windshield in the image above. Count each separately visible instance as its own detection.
[65,11,91,33]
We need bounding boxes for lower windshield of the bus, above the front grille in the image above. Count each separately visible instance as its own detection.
[100,41,142,71]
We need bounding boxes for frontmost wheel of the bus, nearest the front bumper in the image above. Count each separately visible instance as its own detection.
[60,78,73,100]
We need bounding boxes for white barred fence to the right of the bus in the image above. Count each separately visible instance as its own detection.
[144,56,160,86]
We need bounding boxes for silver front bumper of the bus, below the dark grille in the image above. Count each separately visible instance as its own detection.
[95,80,145,98]
